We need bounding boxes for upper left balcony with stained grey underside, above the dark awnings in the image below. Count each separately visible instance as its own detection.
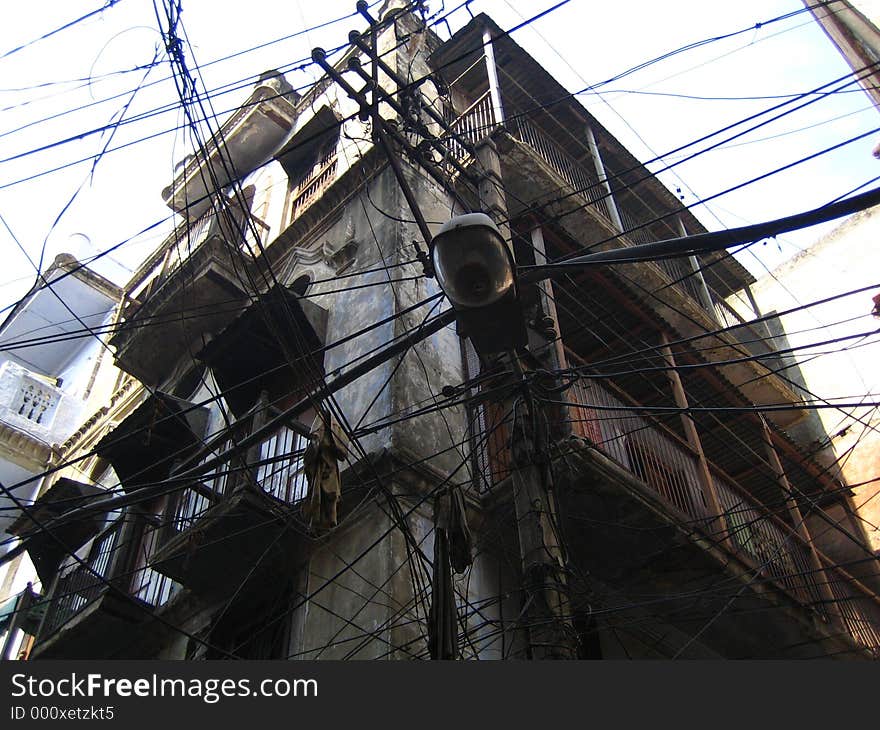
[110,213,251,386]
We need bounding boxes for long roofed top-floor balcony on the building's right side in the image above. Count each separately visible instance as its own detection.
[436,67,806,428]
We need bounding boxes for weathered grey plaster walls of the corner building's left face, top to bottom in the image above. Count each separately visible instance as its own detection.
[24,8,519,659]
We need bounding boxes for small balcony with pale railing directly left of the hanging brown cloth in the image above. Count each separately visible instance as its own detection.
[153,404,307,598]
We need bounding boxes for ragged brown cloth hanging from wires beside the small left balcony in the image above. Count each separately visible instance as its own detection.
[303,411,348,528]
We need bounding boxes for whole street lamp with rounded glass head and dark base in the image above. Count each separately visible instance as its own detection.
[431,213,527,356]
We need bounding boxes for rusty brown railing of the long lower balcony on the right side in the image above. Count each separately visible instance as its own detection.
[473,344,880,656]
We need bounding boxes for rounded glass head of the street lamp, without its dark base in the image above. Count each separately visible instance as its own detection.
[432,213,514,308]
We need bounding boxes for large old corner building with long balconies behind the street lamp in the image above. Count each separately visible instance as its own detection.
[6,2,880,659]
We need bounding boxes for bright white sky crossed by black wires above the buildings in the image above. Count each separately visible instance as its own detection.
[0,0,880,307]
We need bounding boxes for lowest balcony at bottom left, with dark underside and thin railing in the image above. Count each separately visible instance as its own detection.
[32,520,174,659]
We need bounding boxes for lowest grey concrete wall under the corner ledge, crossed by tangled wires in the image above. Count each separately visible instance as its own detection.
[289,492,521,659]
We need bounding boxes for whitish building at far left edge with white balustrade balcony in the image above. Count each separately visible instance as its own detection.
[0,254,122,658]
